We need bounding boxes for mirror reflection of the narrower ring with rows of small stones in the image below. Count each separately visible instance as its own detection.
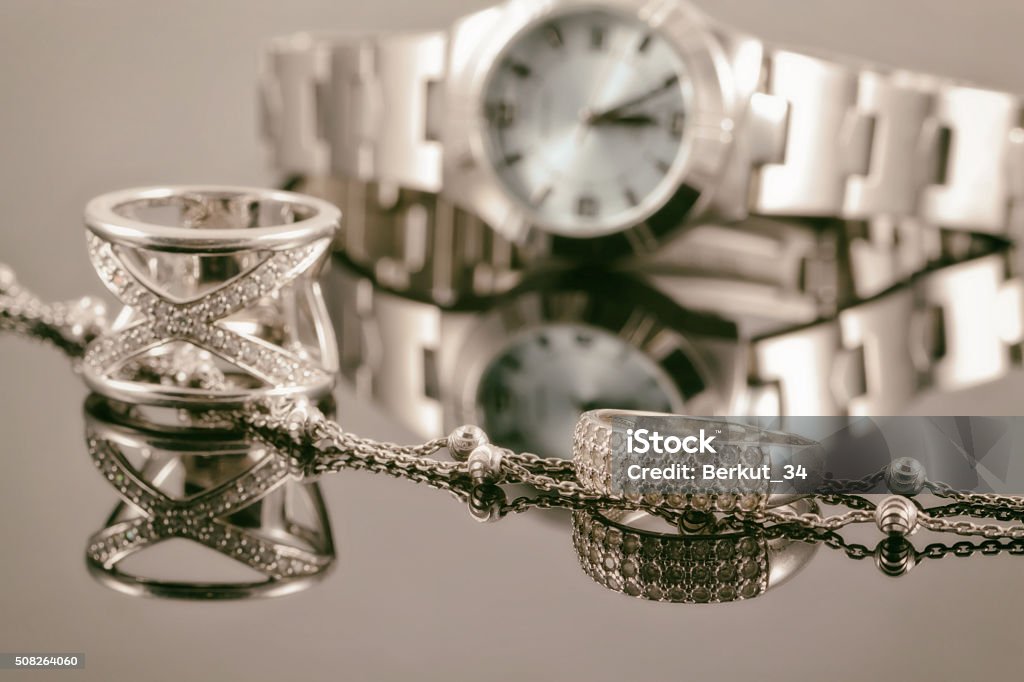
[572,499,817,603]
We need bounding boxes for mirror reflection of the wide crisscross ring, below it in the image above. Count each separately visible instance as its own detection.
[86,395,334,599]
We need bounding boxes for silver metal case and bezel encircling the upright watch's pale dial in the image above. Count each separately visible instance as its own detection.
[442,0,731,253]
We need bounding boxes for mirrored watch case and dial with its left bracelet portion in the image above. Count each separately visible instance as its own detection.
[331,261,742,453]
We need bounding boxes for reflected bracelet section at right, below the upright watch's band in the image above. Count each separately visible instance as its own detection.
[752,245,1024,416]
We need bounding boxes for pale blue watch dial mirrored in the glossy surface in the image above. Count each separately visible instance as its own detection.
[477,325,683,458]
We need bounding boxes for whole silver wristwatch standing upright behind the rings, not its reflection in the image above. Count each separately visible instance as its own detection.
[262,0,1024,297]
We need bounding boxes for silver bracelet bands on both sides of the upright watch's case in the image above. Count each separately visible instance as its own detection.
[261,33,1024,238]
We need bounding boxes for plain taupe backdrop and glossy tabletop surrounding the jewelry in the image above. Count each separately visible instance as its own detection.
[0,0,1024,680]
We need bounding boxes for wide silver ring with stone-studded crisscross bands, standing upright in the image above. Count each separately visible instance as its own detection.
[83,186,340,407]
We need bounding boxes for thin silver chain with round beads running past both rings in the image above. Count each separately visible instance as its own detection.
[6,265,1024,540]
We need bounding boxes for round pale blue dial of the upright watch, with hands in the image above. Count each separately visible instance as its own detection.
[483,10,692,238]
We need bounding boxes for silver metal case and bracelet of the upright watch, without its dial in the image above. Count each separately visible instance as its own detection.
[258,0,1024,295]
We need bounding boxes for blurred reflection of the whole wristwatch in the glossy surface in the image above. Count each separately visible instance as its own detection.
[330,231,1024,455]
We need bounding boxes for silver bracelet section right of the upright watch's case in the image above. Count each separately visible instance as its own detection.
[751,49,1024,233]
